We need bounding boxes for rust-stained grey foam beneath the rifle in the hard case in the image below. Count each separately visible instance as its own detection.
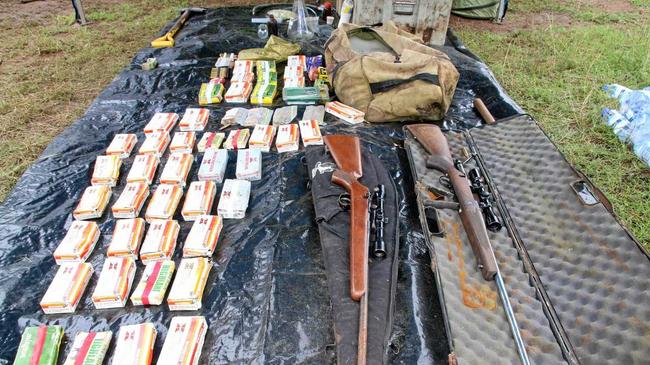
[405,130,565,364]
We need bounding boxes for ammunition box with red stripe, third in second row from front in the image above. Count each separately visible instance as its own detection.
[131,260,176,305]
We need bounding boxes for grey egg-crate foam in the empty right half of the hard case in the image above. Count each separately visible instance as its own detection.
[468,116,650,364]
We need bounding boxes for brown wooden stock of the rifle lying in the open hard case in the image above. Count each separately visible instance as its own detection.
[406,124,497,280]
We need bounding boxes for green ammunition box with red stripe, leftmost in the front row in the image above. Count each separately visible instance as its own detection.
[14,326,63,365]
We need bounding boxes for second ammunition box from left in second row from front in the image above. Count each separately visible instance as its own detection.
[92,257,135,309]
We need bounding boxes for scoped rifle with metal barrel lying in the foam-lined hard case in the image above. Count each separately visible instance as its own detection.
[406,124,530,365]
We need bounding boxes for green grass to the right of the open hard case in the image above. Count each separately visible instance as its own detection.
[459,1,650,247]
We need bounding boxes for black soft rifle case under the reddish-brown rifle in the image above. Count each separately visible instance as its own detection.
[305,146,399,364]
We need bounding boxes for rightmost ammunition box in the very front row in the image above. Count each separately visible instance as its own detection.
[157,316,208,365]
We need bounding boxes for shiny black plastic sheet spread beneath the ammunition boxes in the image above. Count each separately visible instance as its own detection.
[0,8,520,364]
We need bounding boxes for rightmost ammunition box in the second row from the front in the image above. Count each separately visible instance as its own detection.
[167,257,212,310]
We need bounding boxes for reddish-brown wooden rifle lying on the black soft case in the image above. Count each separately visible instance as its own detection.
[323,135,369,365]
